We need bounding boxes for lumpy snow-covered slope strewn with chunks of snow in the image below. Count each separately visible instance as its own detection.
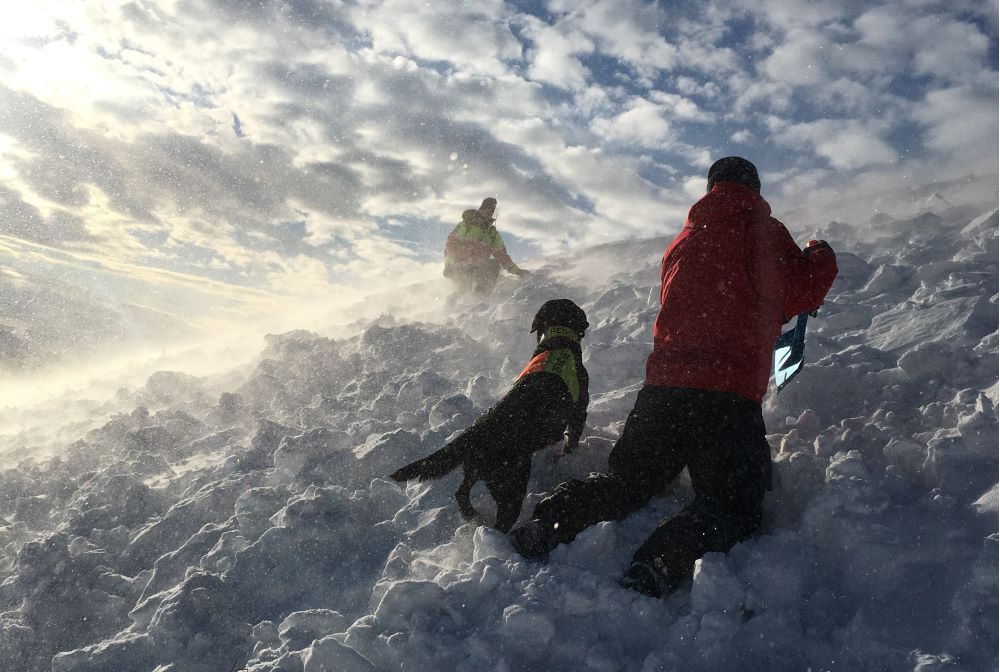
[0,180,998,672]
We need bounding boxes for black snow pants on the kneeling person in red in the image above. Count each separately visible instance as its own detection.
[532,385,771,583]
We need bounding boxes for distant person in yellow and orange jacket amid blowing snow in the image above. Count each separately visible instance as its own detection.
[444,198,527,296]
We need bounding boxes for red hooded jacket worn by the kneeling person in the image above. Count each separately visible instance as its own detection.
[646,182,837,403]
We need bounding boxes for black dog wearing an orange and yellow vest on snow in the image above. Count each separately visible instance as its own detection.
[392,299,590,532]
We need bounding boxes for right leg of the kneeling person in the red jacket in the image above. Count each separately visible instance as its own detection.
[623,393,771,595]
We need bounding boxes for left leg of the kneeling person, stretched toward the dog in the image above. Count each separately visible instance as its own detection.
[511,387,684,557]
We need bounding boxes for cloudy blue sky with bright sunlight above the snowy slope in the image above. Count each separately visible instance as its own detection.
[0,0,998,356]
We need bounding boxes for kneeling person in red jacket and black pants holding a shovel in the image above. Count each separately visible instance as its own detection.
[510,156,837,596]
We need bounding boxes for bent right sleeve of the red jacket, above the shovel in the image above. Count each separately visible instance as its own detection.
[749,217,837,322]
